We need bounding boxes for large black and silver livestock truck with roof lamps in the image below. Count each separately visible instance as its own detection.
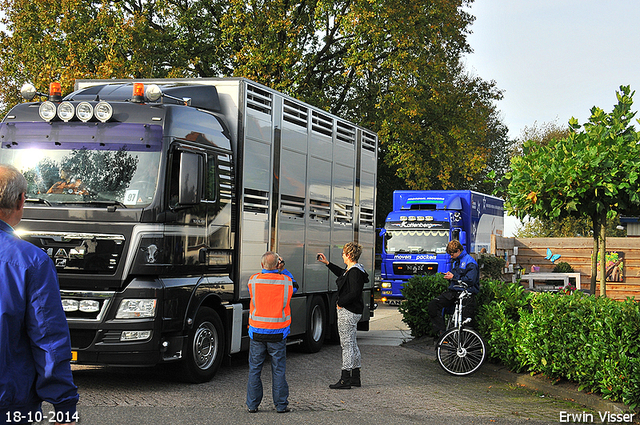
[0,78,377,382]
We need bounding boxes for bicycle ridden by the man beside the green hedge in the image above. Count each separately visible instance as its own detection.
[436,281,487,376]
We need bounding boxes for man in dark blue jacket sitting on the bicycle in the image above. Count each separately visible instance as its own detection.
[428,239,480,341]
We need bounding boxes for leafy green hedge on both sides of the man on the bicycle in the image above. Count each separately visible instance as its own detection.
[400,275,640,409]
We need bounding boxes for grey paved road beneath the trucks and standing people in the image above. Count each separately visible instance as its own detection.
[36,306,600,425]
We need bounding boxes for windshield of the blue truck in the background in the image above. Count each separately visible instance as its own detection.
[385,229,449,254]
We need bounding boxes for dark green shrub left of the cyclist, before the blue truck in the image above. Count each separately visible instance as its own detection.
[398,273,449,338]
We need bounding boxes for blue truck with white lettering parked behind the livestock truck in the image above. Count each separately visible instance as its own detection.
[380,190,504,304]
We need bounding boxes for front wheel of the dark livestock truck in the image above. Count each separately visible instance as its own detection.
[181,307,224,384]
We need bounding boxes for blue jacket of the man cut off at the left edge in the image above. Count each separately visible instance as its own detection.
[0,220,78,422]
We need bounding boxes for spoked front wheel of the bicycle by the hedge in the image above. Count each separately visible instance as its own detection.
[436,329,486,376]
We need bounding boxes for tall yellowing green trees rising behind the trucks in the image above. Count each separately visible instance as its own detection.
[0,0,510,227]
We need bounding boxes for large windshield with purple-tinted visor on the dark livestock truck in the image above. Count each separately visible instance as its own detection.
[0,122,162,207]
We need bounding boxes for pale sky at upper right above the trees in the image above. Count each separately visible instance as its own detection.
[466,0,640,236]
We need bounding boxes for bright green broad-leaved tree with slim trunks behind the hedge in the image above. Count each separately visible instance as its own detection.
[505,86,640,296]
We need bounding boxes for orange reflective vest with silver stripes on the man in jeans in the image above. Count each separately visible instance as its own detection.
[249,273,293,330]
